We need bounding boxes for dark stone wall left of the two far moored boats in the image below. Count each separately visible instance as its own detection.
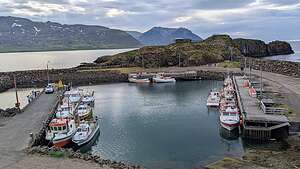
[0,68,127,92]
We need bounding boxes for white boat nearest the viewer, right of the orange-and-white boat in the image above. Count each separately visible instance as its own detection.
[72,120,100,148]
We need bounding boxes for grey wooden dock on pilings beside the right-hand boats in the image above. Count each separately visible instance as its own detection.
[233,76,290,140]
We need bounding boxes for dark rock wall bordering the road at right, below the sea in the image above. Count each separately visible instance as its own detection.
[241,57,300,77]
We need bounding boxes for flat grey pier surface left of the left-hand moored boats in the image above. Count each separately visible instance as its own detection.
[0,94,58,168]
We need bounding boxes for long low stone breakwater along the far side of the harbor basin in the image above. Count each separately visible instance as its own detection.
[0,68,243,92]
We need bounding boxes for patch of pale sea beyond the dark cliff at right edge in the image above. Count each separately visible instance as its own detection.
[266,41,300,62]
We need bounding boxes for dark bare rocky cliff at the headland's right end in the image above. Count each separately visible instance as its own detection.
[233,38,294,58]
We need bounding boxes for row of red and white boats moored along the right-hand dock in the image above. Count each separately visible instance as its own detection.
[207,77,241,131]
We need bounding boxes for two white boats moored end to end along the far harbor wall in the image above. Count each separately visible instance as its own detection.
[128,73,176,83]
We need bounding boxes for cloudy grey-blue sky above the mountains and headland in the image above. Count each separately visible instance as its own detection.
[0,0,300,41]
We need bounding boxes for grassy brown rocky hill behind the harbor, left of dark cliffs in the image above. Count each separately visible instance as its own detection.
[95,35,242,68]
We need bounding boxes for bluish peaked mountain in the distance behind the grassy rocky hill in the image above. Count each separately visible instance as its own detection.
[137,27,202,45]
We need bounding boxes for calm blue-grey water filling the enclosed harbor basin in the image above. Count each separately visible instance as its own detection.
[84,81,243,169]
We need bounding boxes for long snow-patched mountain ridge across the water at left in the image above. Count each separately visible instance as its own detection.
[0,16,141,52]
